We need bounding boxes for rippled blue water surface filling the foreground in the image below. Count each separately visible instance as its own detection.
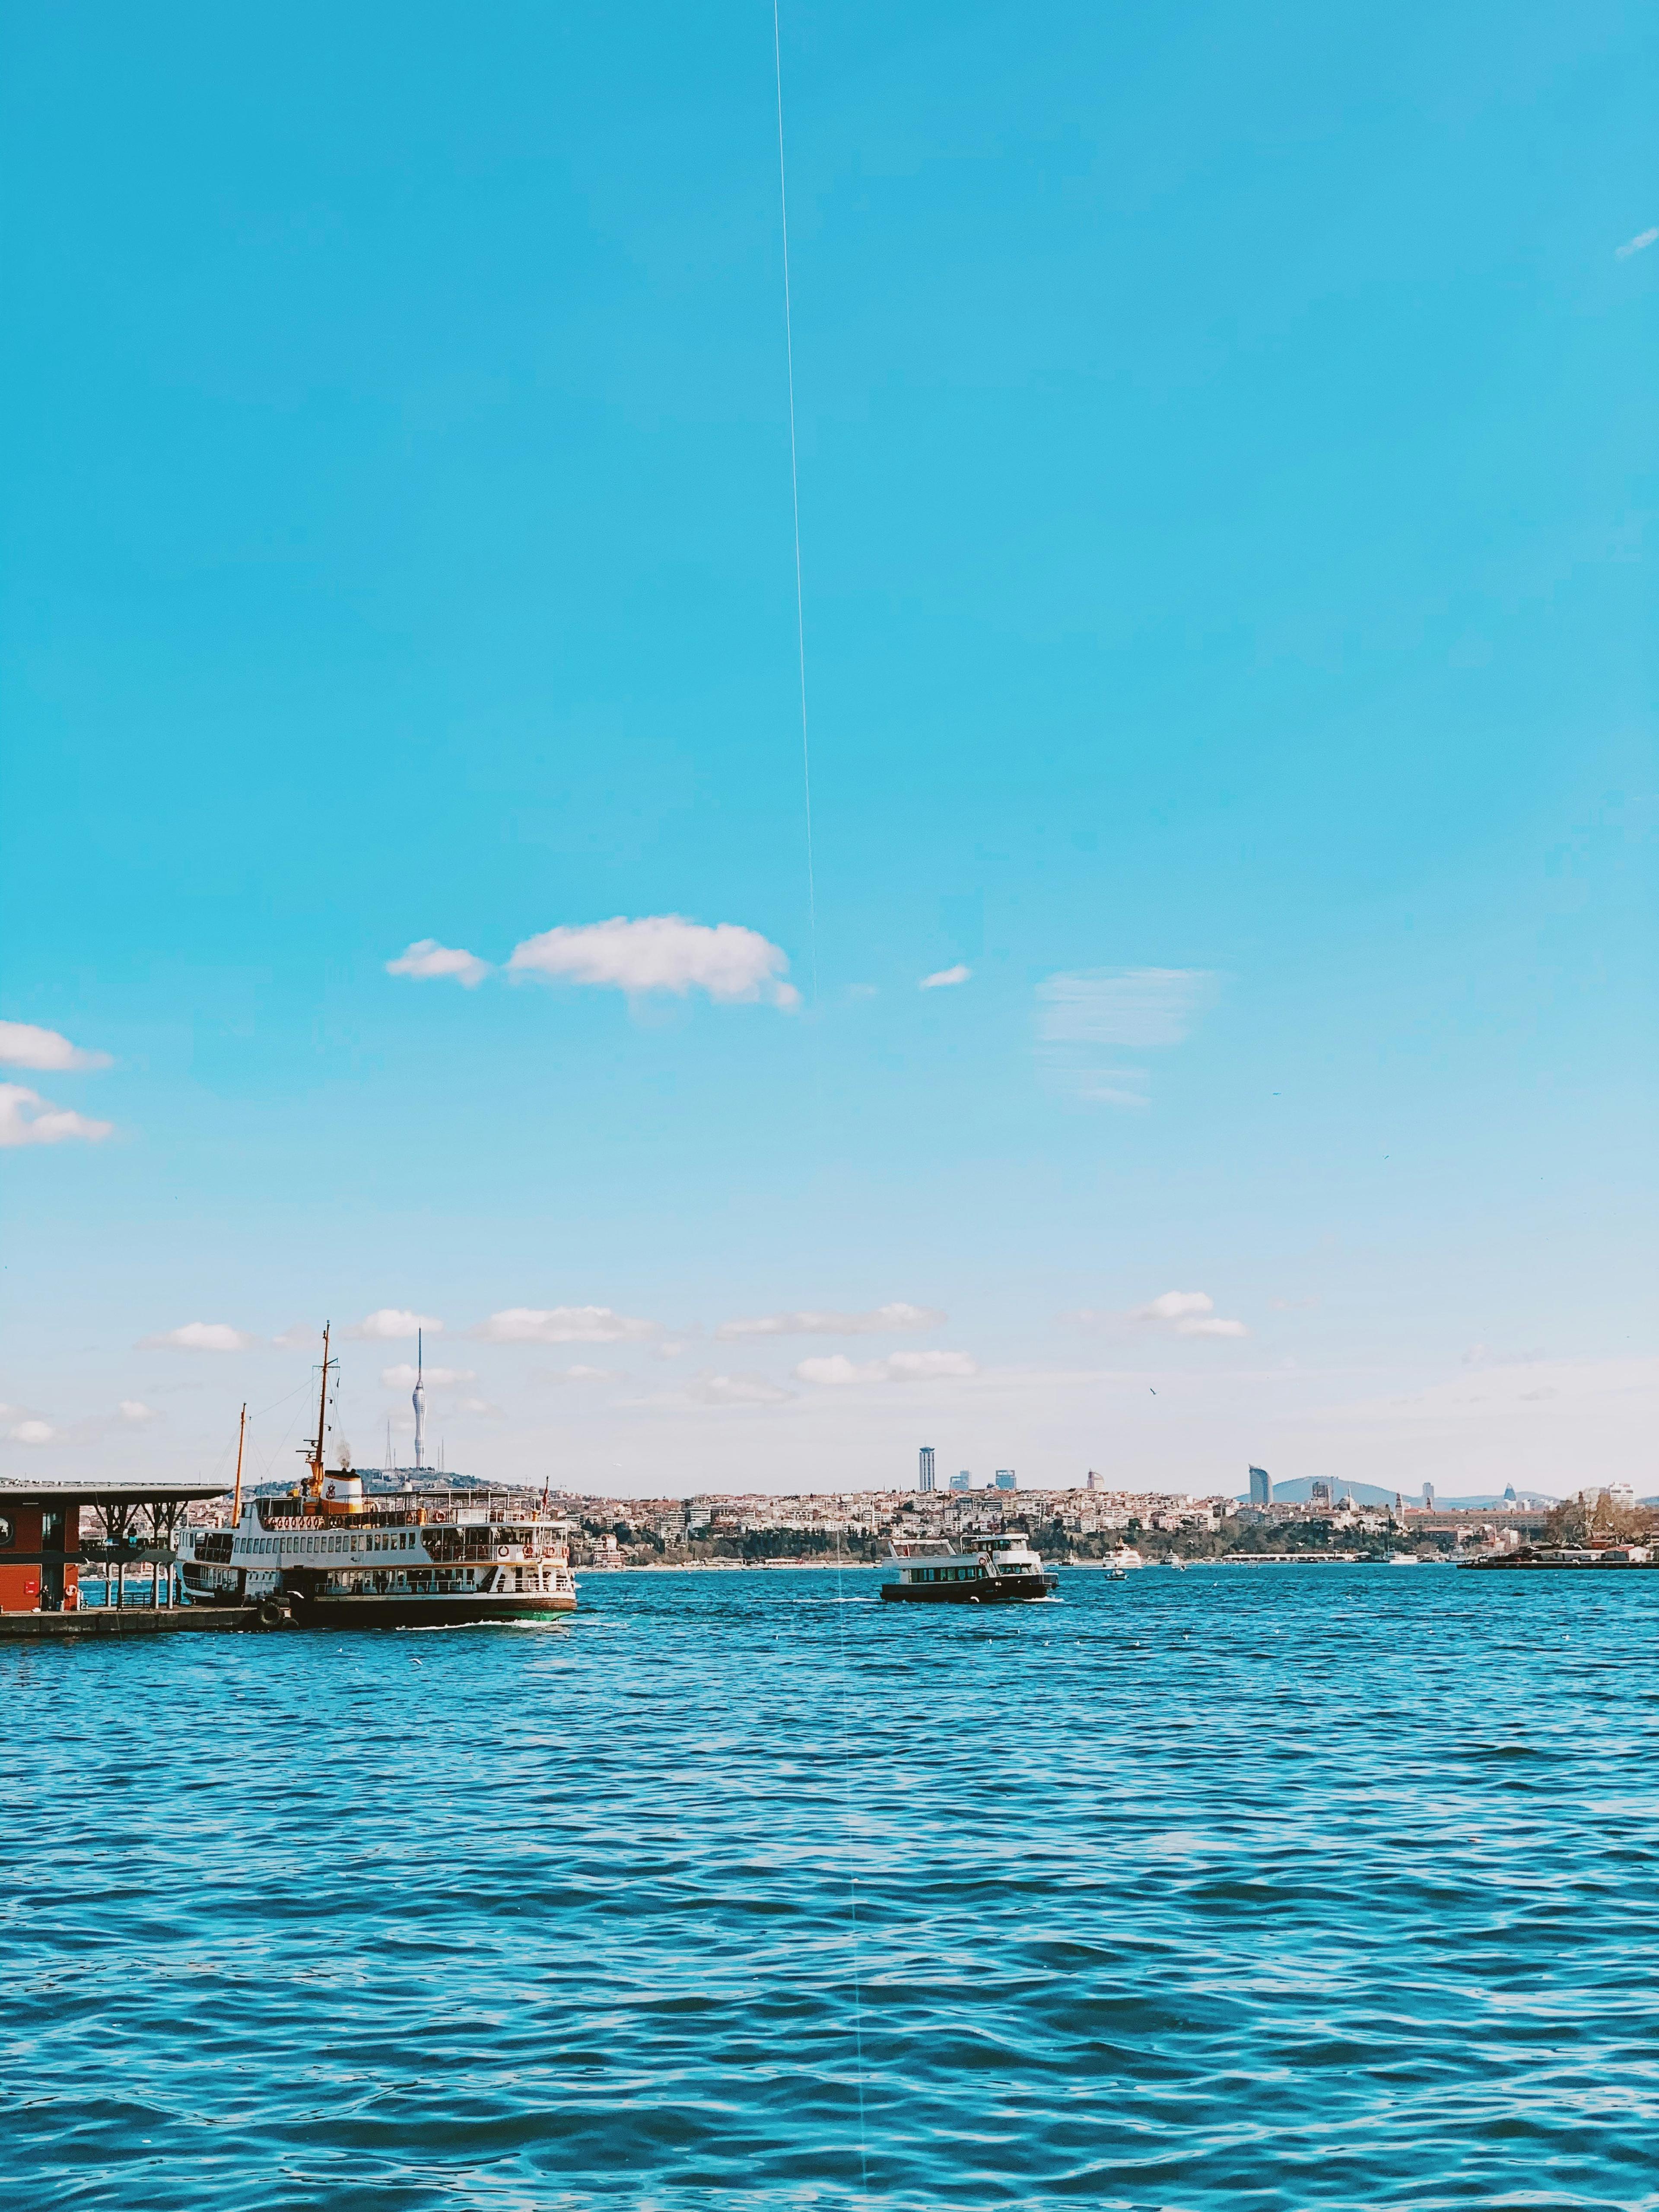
[0,1566,1659,2212]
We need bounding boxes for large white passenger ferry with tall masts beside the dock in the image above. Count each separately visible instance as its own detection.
[179,1329,575,1628]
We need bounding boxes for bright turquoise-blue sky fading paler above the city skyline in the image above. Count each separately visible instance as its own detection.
[0,0,1659,1493]
